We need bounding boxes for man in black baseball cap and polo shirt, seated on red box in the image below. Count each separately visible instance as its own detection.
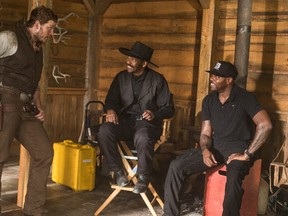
[164,61,272,216]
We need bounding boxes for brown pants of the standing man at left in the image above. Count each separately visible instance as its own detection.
[0,90,53,215]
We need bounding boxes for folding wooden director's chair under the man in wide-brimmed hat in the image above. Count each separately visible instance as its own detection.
[94,119,171,216]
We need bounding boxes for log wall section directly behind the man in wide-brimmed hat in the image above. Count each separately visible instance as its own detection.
[96,1,201,148]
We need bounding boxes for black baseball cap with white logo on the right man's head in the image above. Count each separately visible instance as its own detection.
[206,61,238,80]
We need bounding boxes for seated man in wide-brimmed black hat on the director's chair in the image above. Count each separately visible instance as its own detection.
[98,41,174,193]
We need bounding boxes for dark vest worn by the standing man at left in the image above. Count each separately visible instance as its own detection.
[0,25,43,95]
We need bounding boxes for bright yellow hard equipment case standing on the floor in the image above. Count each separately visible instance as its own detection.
[52,140,98,191]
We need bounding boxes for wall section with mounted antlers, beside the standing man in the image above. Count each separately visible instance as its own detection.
[45,0,89,142]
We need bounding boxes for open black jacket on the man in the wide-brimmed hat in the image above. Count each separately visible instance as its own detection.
[105,67,174,124]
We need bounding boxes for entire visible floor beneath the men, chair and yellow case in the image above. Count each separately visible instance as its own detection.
[1,154,285,216]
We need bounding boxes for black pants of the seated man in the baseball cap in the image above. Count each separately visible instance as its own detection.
[164,149,252,216]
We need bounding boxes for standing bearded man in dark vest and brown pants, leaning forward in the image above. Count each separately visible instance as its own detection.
[0,6,58,216]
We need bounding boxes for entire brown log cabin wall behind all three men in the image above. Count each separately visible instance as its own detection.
[0,0,288,172]
